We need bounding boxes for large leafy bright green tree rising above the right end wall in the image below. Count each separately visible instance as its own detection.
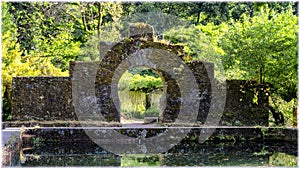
[221,4,298,125]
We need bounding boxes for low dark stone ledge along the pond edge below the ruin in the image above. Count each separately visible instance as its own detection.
[19,126,298,144]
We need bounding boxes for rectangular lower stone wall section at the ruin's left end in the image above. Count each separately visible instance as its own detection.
[12,77,77,121]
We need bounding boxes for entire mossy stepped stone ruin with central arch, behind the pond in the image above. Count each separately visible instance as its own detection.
[12,25,269,126]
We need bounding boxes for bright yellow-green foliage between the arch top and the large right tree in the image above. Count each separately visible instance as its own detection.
[164,23,228,80]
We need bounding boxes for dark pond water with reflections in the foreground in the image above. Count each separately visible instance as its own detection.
[14,141,297,167]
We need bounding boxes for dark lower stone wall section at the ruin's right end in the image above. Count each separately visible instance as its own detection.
[221,80,269,126]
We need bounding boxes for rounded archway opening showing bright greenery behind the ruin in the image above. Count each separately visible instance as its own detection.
[118,66,164,124]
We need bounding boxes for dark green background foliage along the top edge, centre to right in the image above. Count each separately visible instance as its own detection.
[122,1,297,25]
